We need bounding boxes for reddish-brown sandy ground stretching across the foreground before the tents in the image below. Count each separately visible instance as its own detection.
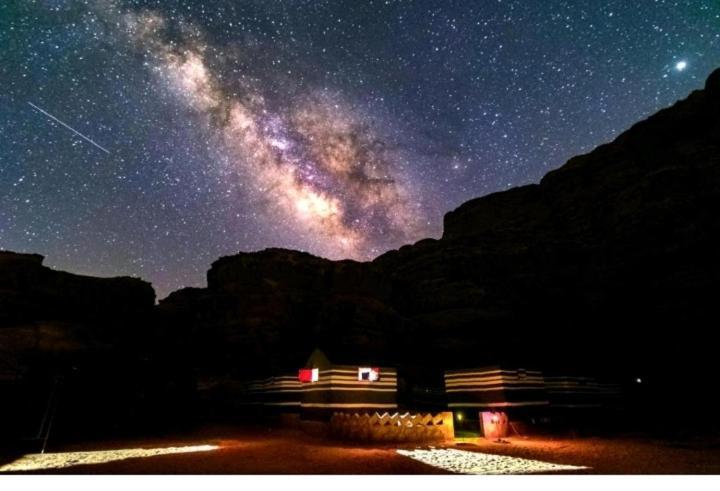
[0,428,720,474]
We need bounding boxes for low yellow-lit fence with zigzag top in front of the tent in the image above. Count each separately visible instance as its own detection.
[330,412,454,442]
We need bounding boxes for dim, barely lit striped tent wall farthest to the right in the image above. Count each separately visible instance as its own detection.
[545,375,620,408]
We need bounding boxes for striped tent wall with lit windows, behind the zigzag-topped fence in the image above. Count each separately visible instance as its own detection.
[301,365,397,412]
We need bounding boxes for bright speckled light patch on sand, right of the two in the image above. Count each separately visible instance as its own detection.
[397,448,587,475]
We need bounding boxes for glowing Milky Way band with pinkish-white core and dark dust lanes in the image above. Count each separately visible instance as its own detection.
[122,8,430,259]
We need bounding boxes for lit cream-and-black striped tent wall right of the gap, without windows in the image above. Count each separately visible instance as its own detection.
[445,366,548,408]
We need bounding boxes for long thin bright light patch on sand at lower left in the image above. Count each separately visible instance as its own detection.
[0,445,219,472]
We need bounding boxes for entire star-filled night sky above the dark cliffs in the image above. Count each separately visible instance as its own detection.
[0,0,720,297]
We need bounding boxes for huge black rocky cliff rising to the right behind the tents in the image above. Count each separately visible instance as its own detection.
[159,71,720,388]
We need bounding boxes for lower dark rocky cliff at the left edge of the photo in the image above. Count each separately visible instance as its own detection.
[0,251,192,440]
